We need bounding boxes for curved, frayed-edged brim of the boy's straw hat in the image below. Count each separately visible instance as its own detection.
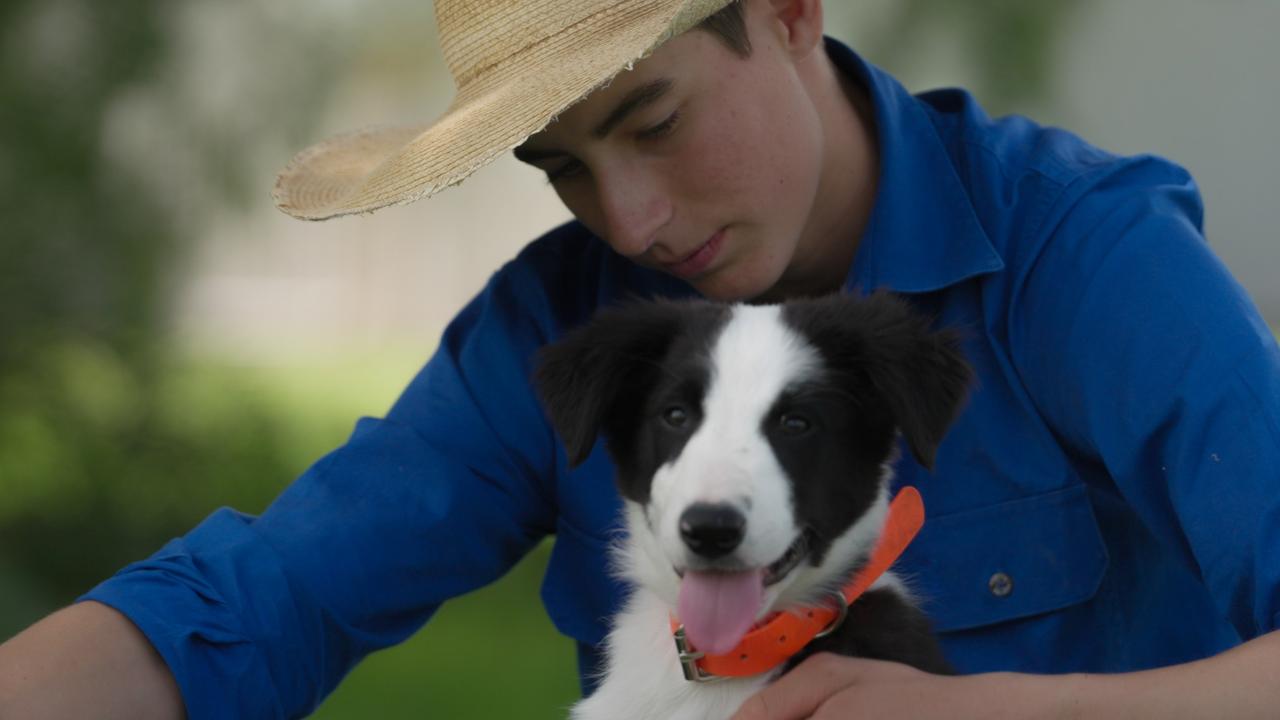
[273,0,726,220]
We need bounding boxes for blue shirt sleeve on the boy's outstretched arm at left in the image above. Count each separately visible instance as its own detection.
[81,261,556,719]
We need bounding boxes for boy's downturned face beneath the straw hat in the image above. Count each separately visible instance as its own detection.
[516,5,823,300]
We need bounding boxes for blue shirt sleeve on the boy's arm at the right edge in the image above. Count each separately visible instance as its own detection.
[1010,159,1280,639]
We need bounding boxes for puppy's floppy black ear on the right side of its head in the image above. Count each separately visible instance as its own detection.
[778,292,973,470]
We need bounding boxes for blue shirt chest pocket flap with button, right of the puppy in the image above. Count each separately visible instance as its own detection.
[900,486,1108,633]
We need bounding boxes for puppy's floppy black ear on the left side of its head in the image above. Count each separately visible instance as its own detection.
[534,302,680,465]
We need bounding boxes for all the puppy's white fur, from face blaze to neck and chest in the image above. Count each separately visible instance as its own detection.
[572,306,901,720]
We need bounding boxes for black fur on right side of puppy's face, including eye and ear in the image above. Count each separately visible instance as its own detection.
[763,293,970,566]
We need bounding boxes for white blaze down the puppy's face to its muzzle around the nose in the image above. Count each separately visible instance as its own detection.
[648,305,820,568]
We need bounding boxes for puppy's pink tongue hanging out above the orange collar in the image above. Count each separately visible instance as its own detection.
[678,569,764,655]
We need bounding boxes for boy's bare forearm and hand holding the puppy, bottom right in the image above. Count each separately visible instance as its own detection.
[733,625,1280,720]
